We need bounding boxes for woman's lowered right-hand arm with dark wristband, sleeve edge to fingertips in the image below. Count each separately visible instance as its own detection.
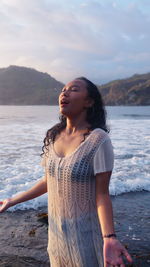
[96,171,132,267]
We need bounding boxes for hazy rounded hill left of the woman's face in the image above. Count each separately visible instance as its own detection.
[0,66,64,105]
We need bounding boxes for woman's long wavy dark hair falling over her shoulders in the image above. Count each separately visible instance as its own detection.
[41,77,110,155]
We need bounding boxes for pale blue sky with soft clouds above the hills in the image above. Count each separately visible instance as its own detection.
[0,0,150,84]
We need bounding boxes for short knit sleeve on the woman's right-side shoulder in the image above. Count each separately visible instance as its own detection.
[94,137,114,175]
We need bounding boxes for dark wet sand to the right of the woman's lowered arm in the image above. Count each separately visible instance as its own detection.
[112,191,150,267]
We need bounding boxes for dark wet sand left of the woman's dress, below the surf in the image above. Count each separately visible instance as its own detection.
[0,208,50,267]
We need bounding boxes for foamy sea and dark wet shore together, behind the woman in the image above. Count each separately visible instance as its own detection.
[0,106,150,267]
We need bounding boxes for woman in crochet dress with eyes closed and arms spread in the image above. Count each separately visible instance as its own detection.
[0,77,132,267]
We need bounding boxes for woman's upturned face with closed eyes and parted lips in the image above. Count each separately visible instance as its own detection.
[59,80,93,116]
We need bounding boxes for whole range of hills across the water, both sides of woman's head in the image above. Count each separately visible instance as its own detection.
[0,66,150,106]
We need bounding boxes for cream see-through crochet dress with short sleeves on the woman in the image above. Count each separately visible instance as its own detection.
[42,128,114,267]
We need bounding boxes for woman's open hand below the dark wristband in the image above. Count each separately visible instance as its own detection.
[103,238,132,267]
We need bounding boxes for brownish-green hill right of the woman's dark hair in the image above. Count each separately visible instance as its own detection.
[99,73,150,106]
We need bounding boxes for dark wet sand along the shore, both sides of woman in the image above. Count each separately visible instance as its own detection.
[0,191,150,267]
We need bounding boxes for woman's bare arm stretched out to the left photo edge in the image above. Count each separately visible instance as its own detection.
[0,177,47,212]
